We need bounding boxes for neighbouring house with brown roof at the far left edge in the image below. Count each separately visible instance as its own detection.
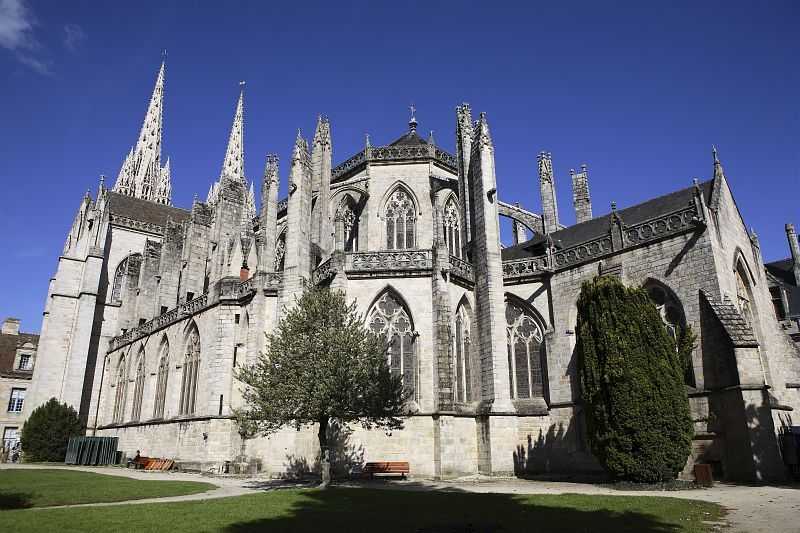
[0,318,39,451]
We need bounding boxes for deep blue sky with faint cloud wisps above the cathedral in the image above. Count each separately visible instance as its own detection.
[0,0,800,331]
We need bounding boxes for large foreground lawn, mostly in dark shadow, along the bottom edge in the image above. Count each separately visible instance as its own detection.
[0,482,722,533]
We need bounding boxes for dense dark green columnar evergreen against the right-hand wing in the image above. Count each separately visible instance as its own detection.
[576,277,694,482]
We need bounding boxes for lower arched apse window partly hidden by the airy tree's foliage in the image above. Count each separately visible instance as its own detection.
[367,290,417,398]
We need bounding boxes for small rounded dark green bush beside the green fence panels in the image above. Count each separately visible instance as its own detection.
[21,398,84,462]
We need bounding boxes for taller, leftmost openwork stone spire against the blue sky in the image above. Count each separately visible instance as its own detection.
[114,62,172,205]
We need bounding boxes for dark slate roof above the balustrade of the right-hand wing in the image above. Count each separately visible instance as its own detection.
[502,180,714,260]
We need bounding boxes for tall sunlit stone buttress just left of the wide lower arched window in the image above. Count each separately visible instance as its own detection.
[469,113,514,413]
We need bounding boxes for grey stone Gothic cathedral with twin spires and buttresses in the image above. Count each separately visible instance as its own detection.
[26,65,800,479]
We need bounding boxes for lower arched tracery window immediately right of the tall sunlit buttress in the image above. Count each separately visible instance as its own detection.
[506,298,544,399]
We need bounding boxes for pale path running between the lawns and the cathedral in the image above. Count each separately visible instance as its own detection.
[0,464,800,533]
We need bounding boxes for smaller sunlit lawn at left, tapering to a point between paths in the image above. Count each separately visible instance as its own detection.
[0,469,216,510]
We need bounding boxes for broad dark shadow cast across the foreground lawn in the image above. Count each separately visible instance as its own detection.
[224,484,682,533]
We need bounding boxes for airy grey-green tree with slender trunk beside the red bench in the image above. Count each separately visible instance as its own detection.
[231,287,408,485]
